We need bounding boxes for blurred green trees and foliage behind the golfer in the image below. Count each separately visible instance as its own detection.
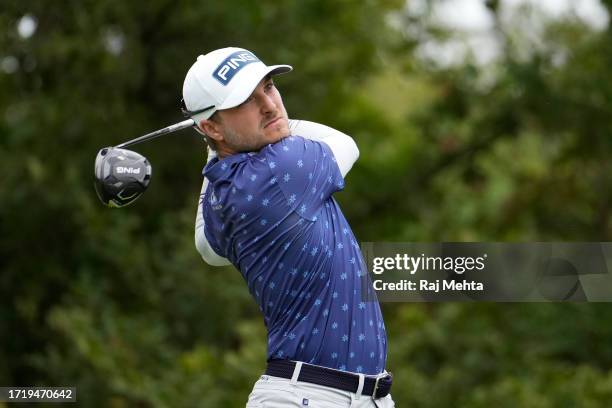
[0,0,612,407]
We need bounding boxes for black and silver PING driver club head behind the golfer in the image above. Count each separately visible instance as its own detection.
[94,147,151,207]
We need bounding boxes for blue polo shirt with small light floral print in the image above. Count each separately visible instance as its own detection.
[202,136,387,374]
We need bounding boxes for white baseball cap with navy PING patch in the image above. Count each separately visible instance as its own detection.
[182,47,293,123]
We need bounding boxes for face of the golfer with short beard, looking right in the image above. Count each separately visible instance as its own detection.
[218,77,290,152]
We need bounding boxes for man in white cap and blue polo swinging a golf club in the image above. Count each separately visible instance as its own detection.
[183,48,393,407]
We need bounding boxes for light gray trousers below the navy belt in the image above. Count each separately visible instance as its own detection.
[246,366,395,408]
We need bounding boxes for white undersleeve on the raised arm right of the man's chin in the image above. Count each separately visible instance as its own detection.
[289,119,359,177]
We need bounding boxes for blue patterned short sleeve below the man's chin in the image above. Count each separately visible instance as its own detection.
[266,136,344,221]
